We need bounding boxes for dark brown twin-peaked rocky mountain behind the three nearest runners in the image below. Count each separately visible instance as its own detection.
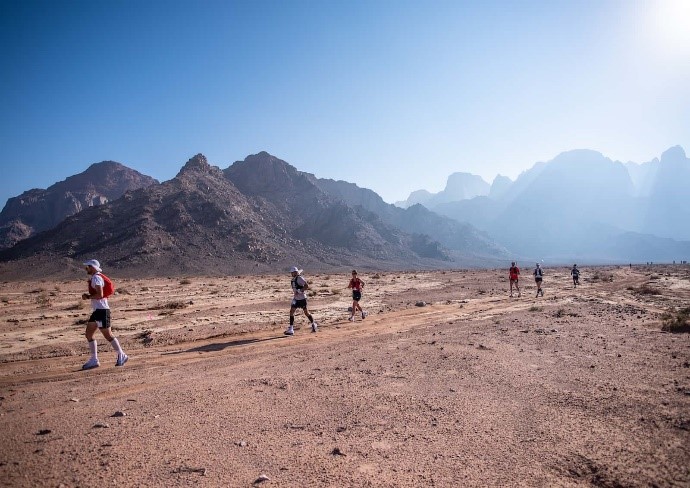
[0,153,462,276]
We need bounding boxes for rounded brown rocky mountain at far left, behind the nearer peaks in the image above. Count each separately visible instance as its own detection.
[0,161,158,249]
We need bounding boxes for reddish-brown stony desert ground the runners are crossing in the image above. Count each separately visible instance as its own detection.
[0,265,690,487]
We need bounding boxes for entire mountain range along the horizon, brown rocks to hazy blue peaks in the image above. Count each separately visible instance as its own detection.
[0,146,690,275]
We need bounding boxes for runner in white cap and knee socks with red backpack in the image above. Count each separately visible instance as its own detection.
[81,259,129,370]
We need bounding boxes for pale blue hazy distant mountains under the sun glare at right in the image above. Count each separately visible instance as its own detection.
[396,146,690,263]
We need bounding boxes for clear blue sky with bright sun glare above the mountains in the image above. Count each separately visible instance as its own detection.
[0,0,690,205]
